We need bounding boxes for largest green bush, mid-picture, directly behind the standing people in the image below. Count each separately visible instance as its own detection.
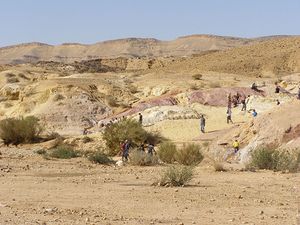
[103,119,161,155]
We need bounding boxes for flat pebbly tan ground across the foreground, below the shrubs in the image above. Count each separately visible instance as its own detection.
[0,147,300,225]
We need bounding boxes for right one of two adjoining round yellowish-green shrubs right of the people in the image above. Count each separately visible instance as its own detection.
[175,144,204,166]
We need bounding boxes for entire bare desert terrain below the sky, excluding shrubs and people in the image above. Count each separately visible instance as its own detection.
[0,35,300,225]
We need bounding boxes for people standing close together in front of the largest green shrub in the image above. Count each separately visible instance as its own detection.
[119,140,156,161]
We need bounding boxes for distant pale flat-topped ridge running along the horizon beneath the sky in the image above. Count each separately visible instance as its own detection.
[0,35,290,64]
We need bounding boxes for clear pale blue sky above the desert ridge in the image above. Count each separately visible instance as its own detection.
[0,0,300,46]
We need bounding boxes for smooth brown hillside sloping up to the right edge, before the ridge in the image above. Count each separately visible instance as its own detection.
[157,37,300,77]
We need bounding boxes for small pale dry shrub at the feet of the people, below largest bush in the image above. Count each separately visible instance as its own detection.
[129,150,158,166]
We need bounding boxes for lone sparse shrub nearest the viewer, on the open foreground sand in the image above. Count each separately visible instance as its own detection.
[159,165,194,186]
